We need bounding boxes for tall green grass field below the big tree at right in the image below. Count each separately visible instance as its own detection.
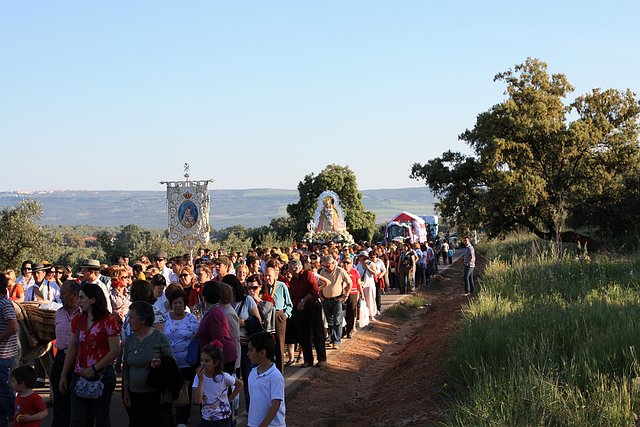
[445,237,640,426]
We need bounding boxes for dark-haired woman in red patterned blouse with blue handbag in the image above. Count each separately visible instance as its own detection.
[59,283,120,427]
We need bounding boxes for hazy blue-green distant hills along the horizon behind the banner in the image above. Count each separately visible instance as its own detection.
[0,186,435,229]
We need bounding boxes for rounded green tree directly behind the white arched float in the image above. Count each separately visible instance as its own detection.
[287,164,375,241]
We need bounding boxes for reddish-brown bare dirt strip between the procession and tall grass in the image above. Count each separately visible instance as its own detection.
[287,260,467,426]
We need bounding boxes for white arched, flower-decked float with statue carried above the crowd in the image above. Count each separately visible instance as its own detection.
[303,190,354,244]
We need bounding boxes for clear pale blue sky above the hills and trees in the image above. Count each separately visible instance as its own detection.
[0,0,640,191]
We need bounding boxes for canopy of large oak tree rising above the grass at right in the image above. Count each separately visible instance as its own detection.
[411,58,640,241]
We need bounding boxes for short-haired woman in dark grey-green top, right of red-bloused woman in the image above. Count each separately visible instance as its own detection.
[122,301,173,427]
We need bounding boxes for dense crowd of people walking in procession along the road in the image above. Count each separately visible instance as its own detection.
[0,241,460,427]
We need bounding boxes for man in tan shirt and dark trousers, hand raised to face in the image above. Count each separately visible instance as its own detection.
[320,255,352,348]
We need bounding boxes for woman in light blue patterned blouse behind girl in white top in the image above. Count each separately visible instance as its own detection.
[164,288,199,425]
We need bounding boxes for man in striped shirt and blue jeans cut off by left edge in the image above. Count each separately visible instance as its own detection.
[0,274,18,427]
